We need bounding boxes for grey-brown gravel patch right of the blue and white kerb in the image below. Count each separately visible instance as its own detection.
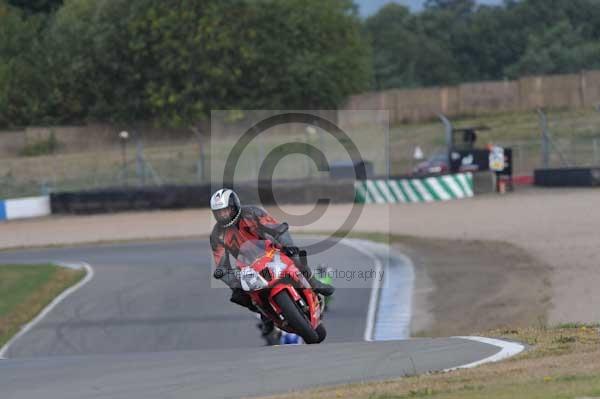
[394,237,552,337]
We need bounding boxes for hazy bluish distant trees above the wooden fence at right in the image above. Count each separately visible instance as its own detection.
[365,0,600,89]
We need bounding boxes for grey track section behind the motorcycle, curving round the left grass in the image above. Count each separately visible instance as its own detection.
[0,240,373,358]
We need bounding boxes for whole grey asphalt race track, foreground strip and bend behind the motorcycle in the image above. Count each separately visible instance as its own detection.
[0,240,516,399]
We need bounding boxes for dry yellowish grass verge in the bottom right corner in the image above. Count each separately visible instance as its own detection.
[264,325,600,399]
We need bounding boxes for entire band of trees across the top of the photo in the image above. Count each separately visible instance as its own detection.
[0,0,600,127]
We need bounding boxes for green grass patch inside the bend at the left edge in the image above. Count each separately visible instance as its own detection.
[0,264,85,347]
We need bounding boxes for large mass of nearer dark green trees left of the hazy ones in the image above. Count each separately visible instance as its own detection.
[42,0,370,126]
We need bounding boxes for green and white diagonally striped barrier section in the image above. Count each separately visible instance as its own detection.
[354,173,473,204]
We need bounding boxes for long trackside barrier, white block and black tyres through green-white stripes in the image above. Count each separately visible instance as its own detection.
[0,173,477,220]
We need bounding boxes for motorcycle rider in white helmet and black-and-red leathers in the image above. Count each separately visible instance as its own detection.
[210,188,334,335]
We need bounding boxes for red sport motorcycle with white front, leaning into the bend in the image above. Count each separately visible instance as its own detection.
[237,240,327,344]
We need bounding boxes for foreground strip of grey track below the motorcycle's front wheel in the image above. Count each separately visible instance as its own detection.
[0,338,498,399]
